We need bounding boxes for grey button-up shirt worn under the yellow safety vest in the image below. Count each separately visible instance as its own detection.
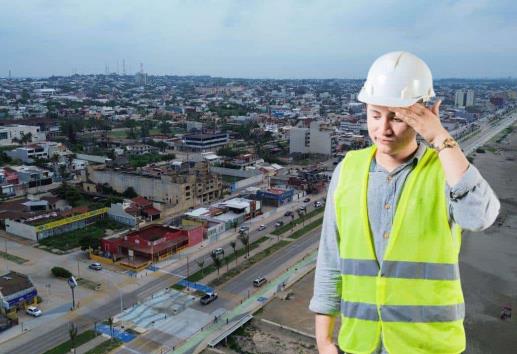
[309,144,500,353]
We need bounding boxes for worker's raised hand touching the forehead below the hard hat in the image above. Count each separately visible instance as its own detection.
[390,100,449,145]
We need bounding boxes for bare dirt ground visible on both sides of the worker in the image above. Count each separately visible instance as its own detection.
[214,126,517,354]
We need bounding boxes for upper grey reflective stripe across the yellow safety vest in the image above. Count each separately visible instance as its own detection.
[340,258,460,280]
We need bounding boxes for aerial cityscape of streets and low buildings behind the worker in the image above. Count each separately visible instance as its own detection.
[0,0,517,354]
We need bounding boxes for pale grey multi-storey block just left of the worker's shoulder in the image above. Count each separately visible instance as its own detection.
[289,121,338,156]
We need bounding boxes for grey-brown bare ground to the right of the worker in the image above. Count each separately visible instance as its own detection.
[461,125,517,353]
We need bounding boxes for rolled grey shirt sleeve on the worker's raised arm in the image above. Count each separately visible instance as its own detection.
[446,165,501,231]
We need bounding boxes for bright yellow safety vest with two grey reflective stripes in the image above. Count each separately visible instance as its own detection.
[334,146,465,354]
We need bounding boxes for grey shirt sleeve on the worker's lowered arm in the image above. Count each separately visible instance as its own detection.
[309,163,341,315]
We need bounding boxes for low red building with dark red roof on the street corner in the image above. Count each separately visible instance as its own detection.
[101,225,203,269]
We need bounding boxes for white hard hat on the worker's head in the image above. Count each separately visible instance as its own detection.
[357,52,435,107]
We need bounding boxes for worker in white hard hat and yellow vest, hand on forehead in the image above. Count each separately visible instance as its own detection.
[309,52,500,354]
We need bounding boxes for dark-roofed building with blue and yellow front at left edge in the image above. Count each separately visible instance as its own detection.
[0,271,38,314]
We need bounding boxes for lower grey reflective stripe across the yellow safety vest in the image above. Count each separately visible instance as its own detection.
[341,301,465,322]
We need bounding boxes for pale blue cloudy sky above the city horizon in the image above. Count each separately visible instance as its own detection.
[0,0,517,79]
